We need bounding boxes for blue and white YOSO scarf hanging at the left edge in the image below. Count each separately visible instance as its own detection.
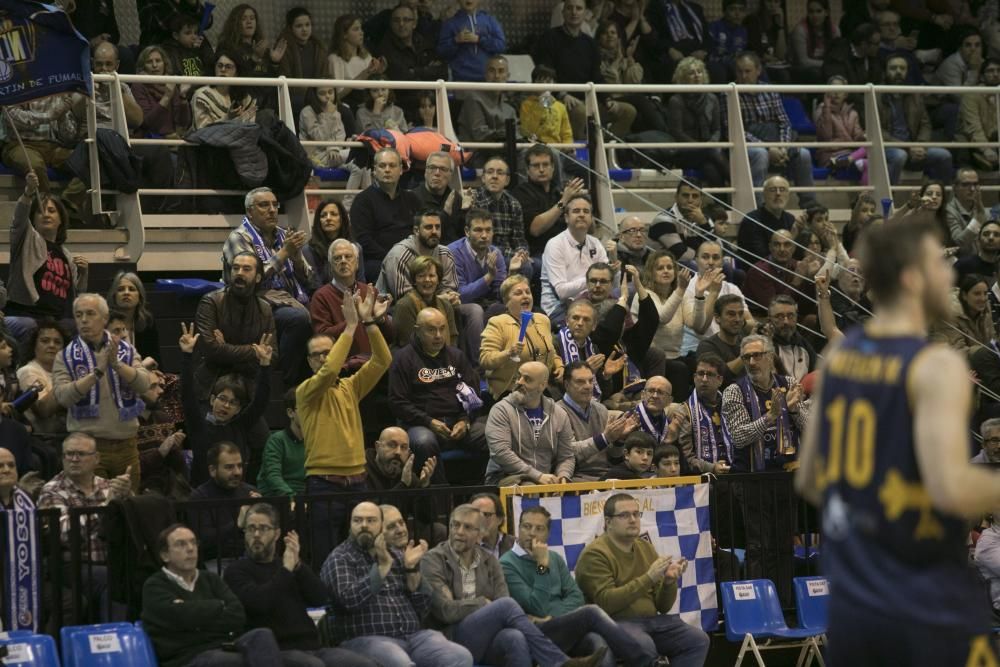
[3,487,41,632]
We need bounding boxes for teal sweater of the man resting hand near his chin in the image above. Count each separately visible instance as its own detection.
[500,544,585,618]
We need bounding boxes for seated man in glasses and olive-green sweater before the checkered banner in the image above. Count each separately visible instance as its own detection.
[576,493,710,667]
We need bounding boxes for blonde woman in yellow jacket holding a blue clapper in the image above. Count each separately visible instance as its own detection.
[479,273,563,399]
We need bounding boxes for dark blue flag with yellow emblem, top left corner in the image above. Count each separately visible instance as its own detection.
[0,0,92,105]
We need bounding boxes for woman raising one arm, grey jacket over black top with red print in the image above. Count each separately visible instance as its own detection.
[4,173,89,340]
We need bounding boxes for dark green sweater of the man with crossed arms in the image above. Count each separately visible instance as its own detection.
[142,570,246,667]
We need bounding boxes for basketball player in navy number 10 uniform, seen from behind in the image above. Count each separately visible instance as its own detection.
[795,217,1000,667]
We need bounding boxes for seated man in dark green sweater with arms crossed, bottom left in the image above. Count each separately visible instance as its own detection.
[142,523,281,667]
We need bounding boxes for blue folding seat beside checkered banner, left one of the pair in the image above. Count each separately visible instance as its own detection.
[722,579,826,667]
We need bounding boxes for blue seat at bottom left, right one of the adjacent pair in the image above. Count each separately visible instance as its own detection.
[61,623,157,667]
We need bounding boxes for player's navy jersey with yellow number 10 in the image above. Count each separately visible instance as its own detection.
[813,327,984,629]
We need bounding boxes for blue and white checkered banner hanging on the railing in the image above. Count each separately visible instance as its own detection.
[512,483,719,632]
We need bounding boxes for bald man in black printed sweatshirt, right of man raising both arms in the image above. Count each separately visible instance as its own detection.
[389,308,486,470]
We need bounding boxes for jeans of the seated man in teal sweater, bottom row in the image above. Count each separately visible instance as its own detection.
[539,604,658,667]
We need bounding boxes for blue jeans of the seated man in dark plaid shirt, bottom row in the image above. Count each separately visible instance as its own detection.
[340,630,472,667]
